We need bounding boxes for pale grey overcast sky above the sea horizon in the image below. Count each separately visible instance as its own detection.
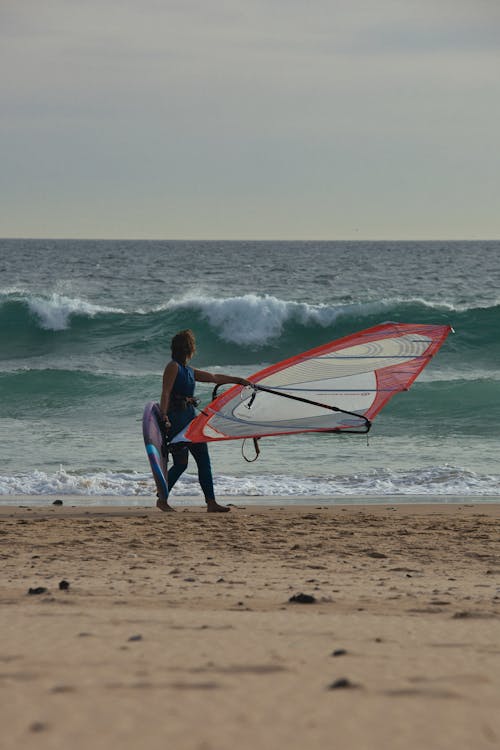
[0,0,500,240]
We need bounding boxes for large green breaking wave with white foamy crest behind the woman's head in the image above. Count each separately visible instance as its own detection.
[0,292,500,364]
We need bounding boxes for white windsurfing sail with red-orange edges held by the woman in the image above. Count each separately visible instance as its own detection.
[172,323,452,443]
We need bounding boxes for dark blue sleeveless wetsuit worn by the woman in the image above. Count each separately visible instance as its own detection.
[167,360,215,500]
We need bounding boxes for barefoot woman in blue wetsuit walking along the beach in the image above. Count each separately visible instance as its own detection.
[156,329,249,513]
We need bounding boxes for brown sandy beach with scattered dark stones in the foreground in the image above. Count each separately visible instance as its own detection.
[0,497,500,750]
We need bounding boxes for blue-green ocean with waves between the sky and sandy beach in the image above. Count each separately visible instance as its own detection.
[0,239,500,505]
